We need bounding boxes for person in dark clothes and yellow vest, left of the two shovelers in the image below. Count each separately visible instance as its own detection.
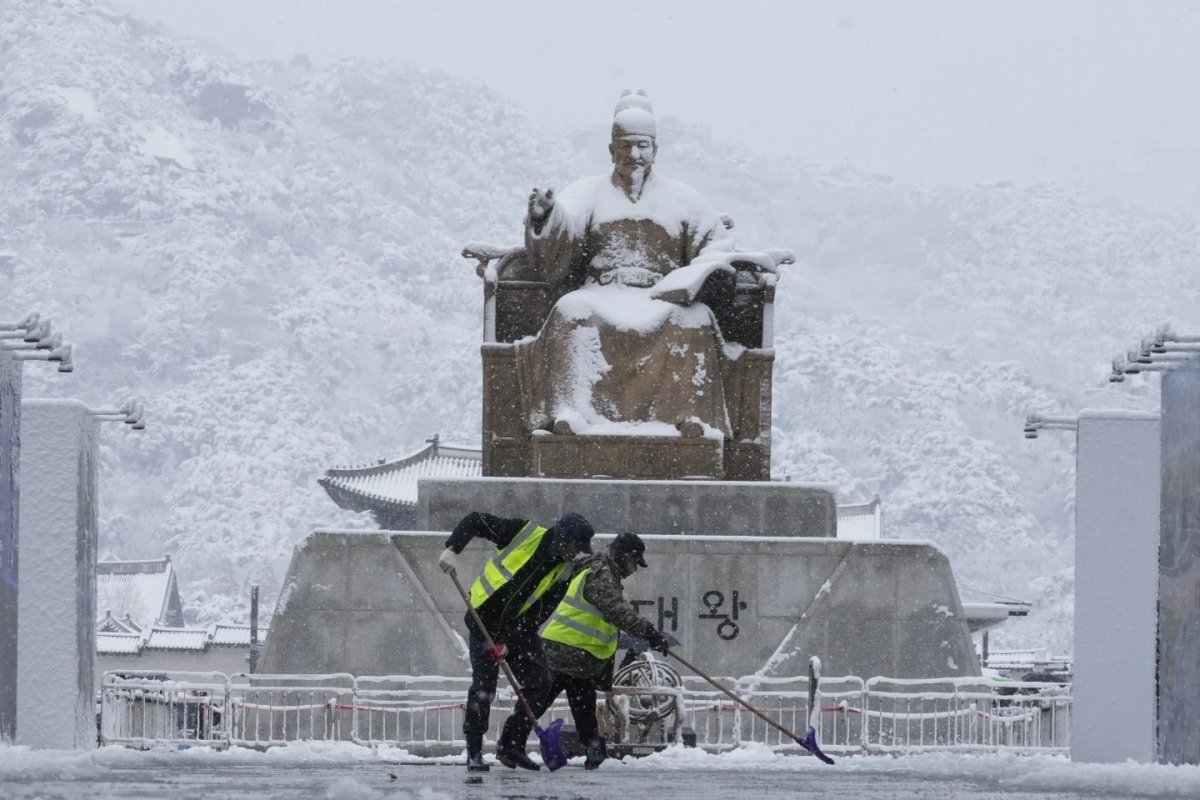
[438,511,594,771]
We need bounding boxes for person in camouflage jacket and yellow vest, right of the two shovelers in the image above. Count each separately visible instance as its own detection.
[497,534,668,769]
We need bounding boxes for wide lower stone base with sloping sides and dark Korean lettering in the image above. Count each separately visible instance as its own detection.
[260,530,979,678]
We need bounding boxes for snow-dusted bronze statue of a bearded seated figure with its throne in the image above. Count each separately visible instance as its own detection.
[464,92,791,480]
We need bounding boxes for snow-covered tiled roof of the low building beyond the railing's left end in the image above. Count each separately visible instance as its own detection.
[96,555,184,628]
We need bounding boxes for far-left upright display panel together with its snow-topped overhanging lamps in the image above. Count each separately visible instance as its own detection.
[0,313,74,742]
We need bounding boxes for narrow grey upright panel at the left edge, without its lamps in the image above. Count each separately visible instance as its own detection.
[0,350,20,742]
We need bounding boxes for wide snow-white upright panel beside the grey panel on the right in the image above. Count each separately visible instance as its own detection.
[1070,411,1159,763]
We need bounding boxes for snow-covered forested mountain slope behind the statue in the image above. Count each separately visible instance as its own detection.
[7,0,1200,650]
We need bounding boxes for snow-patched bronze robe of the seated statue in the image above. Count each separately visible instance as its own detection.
[516,172,740,437]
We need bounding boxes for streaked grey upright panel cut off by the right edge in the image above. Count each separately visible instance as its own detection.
[1158,367,1200,764]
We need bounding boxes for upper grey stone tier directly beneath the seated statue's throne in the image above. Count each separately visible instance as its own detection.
[416,477,838,537]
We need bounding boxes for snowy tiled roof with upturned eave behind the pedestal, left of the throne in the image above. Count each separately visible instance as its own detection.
[317,437,484,511]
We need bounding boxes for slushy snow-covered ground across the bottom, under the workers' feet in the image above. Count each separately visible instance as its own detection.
[0,744,1200,800]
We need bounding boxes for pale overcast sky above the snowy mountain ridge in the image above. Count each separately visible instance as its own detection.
[113,0,1200,213]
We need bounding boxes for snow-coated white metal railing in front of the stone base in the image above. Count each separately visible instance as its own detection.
[100,672,1072,756]
